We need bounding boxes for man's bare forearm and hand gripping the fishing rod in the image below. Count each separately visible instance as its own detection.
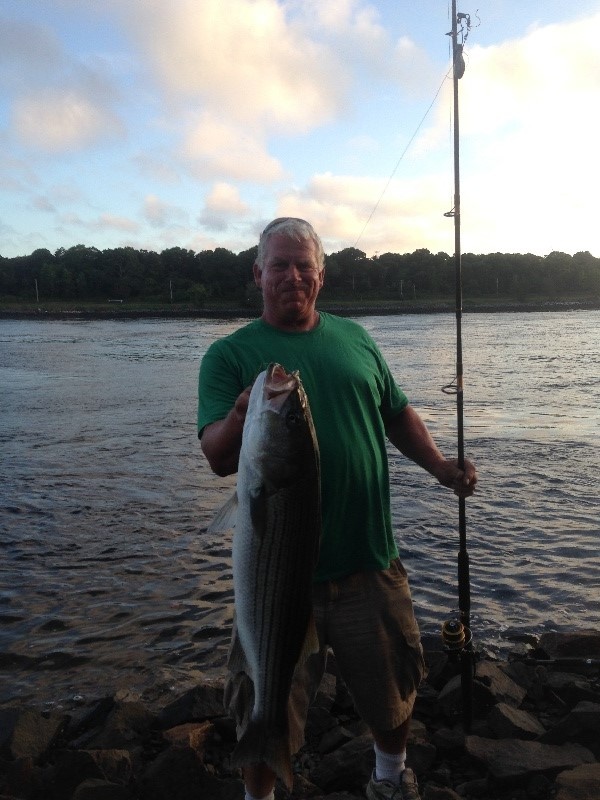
[386,405,477,497]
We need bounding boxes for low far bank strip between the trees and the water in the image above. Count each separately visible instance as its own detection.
[0,300,600,320]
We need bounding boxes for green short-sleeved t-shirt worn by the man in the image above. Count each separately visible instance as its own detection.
[198,312,408,581]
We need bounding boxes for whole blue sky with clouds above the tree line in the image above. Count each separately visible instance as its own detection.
[0,0,600,257]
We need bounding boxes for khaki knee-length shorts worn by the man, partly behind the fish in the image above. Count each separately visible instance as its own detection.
[225,559,426,752]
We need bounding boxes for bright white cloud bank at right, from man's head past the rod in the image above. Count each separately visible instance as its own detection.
[277,10,600,255]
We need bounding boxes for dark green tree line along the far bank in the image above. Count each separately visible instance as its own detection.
[0,244,600,307]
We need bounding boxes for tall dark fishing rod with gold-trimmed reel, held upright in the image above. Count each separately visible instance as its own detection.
[442,0,475,732]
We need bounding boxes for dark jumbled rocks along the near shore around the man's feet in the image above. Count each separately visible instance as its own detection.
[0,631,600,800]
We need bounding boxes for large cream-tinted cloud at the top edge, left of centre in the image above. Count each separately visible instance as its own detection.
[120,0,343,133]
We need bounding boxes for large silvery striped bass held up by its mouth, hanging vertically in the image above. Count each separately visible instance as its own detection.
[212,364,321,789]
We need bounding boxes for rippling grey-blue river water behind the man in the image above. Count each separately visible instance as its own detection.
[0,311,600,708]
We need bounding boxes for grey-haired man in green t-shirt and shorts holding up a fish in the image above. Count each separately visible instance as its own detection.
[198,217,477,800]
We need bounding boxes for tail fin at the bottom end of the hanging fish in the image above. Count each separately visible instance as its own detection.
[231,720,294,792]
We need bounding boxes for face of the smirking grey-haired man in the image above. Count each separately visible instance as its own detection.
[254,234,324,326]
